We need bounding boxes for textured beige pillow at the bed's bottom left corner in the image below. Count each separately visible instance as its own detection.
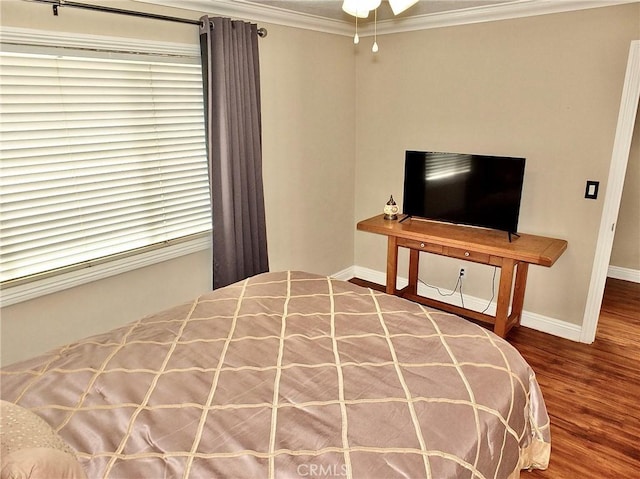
[0,401,86,479]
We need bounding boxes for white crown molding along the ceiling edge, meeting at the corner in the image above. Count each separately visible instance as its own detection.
[134,0,640,36]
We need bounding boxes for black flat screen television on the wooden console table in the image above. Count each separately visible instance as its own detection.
[402,151,525,239]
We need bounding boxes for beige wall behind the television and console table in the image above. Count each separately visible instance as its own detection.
[355,4,640,325]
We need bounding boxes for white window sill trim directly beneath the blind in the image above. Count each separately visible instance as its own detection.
[0,236,211,308]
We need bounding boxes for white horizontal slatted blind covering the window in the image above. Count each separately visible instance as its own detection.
[0,47,211,282]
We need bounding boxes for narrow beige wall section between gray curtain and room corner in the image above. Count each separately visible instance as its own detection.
[260,25,355,274]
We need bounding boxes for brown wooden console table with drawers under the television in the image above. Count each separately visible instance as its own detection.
[358,215,567,338]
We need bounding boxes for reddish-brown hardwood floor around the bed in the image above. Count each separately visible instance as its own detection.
[352,278,640,479]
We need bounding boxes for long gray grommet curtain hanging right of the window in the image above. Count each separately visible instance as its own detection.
[200,16,269,288]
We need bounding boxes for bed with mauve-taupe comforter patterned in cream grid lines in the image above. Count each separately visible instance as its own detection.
[0,271,550,479]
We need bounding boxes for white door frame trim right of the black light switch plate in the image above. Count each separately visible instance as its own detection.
[580,40,640,344]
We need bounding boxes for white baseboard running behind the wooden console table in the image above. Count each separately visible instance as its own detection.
[332,266,581,341]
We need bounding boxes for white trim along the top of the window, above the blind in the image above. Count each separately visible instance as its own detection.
[0,26,200,58]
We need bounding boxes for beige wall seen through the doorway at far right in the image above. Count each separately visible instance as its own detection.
[610,104,640,271]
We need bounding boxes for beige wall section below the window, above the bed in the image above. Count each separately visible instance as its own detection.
[1,251,211,365]
